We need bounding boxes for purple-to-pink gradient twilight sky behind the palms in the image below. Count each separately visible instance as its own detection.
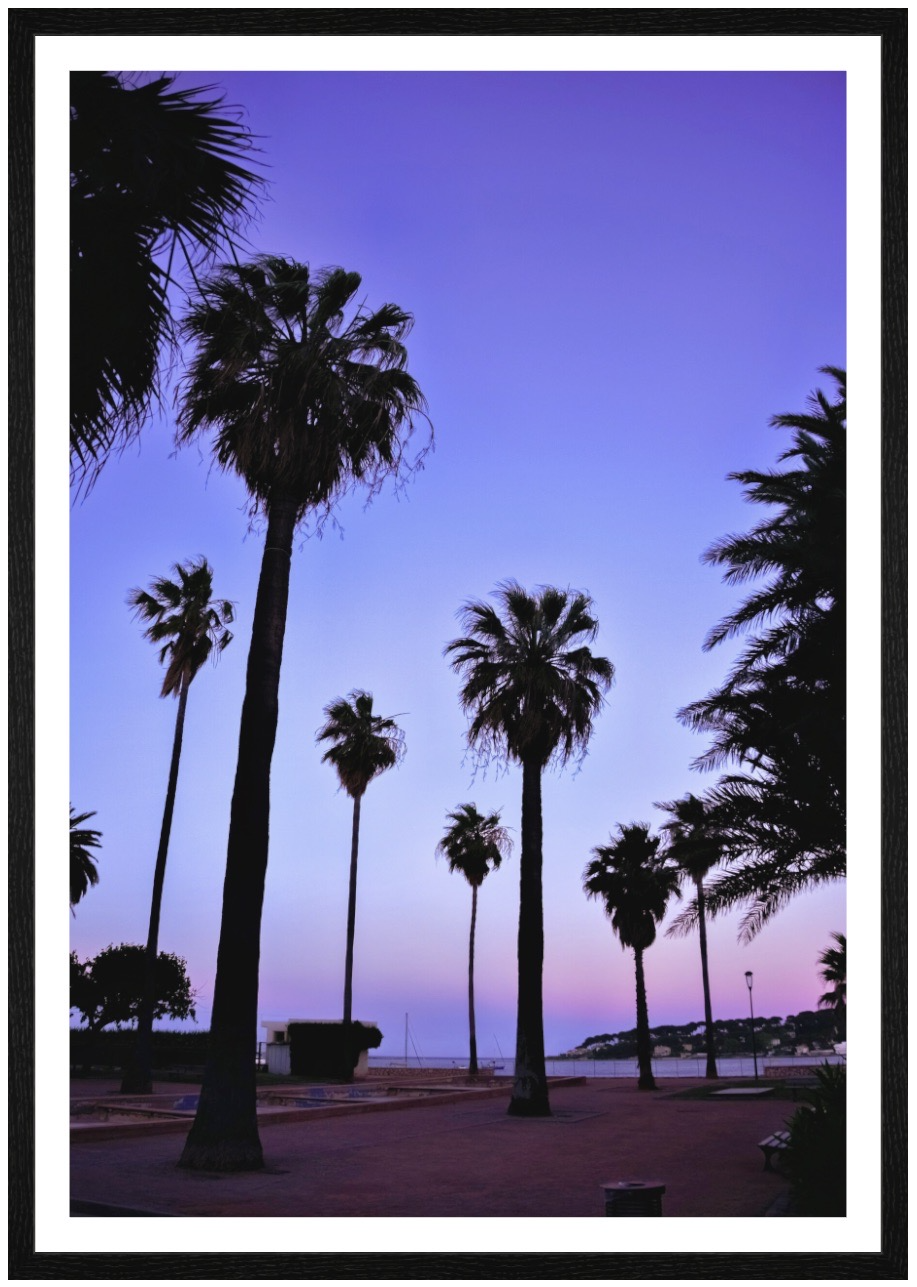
[69,62,846,1057]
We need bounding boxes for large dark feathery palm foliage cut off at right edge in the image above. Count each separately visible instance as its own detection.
[679,367,846,940]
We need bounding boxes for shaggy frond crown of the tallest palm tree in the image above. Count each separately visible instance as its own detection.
[177,256,428,521]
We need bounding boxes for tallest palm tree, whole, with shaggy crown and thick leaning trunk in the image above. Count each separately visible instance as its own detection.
[179,256,426,1170]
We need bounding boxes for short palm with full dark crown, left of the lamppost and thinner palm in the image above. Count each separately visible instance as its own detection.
[583,822,678,1090]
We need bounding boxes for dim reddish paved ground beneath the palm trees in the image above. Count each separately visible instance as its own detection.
[71,1079,792,1216]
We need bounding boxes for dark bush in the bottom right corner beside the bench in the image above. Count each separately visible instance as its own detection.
[783,1063,848,1215]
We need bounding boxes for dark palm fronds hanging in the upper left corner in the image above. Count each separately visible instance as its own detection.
[69,72,262,485]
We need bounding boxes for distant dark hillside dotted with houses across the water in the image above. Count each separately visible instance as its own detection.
[553,1010,844,1059]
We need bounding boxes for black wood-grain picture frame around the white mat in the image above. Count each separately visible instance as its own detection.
[8,8,907,1281]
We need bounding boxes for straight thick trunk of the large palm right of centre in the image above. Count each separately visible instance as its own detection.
[509,759,550,1117]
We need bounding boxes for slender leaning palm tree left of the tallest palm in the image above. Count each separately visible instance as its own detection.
[121,556,233,1095]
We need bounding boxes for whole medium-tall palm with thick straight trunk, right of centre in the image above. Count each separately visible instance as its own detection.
[445,580,615,1117]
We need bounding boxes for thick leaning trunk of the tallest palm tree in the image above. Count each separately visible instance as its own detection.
[179,497,297,1171]
